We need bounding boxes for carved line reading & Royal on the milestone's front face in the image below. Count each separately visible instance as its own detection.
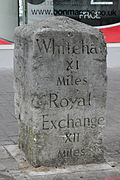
[31,93,90,108]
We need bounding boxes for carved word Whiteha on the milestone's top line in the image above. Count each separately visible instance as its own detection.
[36,38,99,55]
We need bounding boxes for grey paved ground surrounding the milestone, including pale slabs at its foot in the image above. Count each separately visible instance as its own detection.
[0,68,120,180]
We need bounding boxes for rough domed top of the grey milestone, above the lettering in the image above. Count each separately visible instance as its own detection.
[14,16,105,44]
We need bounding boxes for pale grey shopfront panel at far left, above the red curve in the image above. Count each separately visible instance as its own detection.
[0,0,18,41]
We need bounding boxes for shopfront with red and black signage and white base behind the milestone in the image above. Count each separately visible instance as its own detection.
[0,0,120,68]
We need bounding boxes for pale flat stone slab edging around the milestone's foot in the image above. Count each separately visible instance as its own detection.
[5,145,114,180]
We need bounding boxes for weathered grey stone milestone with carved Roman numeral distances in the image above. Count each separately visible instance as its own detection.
[14,17,107,167]
